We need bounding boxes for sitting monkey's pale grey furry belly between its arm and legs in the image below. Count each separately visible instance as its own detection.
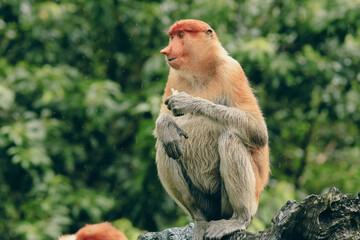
[175,115,221,193]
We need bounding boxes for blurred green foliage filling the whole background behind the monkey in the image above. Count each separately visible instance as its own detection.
[0,0,360,239]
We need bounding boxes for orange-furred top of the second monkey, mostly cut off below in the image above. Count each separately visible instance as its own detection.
[59,222,127,240]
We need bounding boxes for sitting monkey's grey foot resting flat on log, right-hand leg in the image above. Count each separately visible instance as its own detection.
[205,219,246,240]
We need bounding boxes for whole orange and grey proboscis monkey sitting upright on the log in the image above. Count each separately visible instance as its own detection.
[154,20,270,240]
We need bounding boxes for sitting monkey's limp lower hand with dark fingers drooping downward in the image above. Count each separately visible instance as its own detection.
[156,114,188,159]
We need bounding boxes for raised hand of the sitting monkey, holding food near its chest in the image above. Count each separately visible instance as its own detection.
[165,92,199,117]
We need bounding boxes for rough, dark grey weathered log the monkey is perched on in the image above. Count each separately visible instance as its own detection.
[138,188,360,240]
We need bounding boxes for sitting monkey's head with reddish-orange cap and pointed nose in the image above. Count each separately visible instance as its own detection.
[160,19,219,71]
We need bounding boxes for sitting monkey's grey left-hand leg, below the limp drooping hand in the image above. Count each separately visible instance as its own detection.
[156,142,209,240]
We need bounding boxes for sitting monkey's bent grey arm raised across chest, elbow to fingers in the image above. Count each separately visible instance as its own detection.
[165,92,268,148]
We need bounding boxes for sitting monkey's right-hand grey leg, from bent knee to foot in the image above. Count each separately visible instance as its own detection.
[206,130,257,239]
